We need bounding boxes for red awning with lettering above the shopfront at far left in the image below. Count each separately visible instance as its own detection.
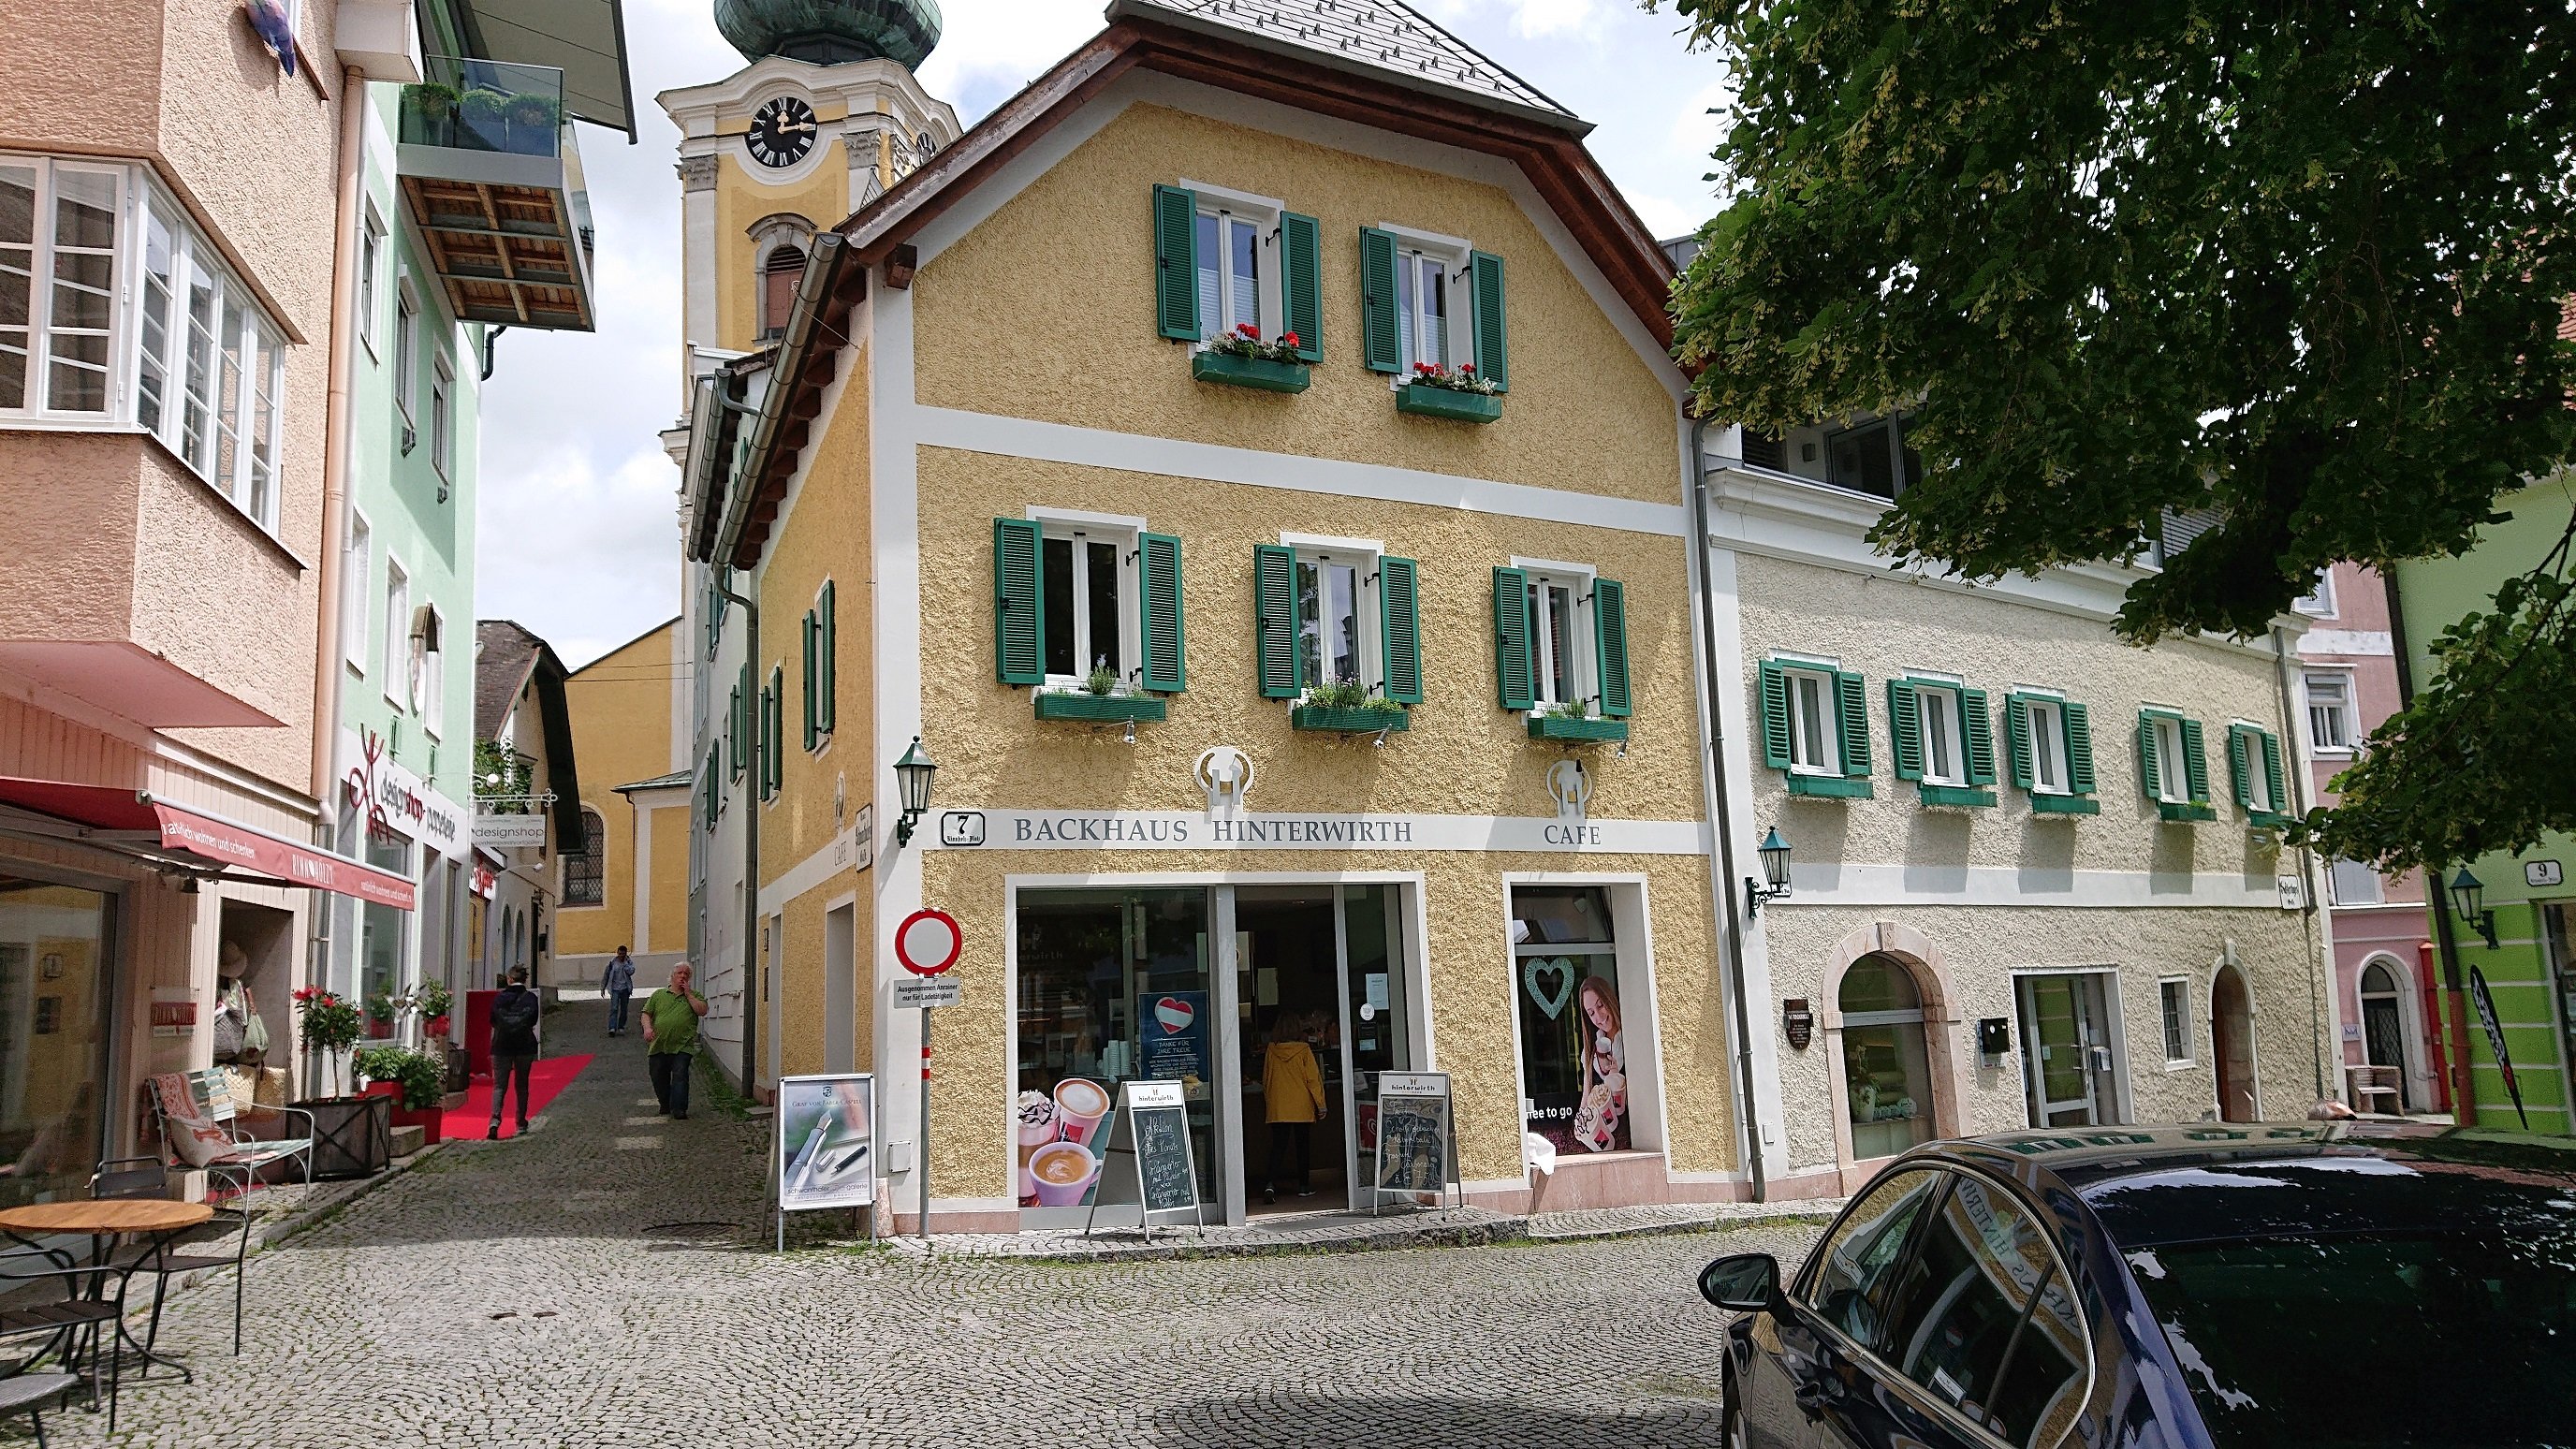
[0,776,417,910]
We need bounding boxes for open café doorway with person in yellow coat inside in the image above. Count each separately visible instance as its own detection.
[1229,885,1412,1217]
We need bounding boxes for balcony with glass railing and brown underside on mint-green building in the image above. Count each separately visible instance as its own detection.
[394,57,595,332]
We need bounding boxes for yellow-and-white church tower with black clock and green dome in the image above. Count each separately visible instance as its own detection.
[657,0,959,358]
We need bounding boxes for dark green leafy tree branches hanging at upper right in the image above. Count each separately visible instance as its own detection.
[1675,0,2576,864]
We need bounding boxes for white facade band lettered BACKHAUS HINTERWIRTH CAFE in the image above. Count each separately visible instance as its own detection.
[932,810,1708,856]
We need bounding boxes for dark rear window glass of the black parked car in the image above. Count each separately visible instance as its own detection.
[2128,1217,2576,1449]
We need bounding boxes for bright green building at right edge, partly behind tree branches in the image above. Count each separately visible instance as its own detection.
[2391,472,2576,1134]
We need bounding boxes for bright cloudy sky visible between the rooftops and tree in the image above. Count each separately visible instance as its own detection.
[476,0,1723,667]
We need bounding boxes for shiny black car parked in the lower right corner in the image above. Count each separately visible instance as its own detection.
[1700,1121,2576,1449]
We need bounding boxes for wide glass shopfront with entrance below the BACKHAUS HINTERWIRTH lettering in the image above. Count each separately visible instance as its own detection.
[1010,879,1429,1227]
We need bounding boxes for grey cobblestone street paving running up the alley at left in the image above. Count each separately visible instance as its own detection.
[47,1005,1813,1449]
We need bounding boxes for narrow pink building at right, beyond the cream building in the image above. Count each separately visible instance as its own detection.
[2298,564,2450,1111]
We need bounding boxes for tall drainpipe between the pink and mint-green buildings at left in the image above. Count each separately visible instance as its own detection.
[304,65,366,1065]
